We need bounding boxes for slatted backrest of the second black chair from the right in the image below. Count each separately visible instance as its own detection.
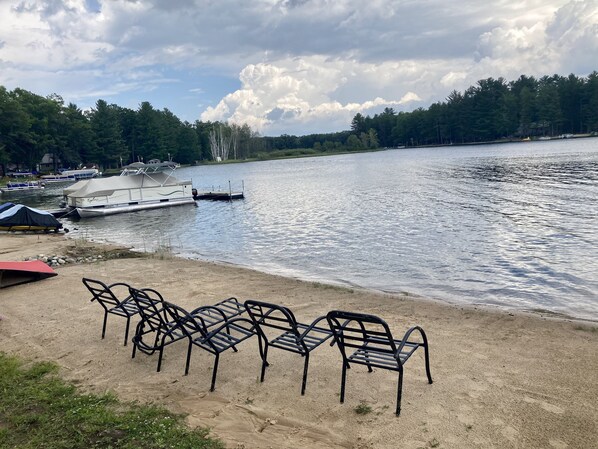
[245,299,300,341]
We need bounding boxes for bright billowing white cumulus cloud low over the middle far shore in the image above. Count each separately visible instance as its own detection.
[201,56,428,134]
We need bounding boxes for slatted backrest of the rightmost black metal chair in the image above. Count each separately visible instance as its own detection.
[326,310,397,358]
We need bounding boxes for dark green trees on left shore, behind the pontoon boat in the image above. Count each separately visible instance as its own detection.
[0,86,264,170]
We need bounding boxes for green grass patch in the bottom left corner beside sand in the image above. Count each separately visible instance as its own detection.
[0,352,224,449]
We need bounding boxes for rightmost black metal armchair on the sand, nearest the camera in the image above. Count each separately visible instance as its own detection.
[326,310,432,416]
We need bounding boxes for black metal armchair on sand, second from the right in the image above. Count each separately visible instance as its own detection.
[245,300,332,395]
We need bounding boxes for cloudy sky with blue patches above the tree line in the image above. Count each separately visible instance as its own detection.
[0,0,598,136]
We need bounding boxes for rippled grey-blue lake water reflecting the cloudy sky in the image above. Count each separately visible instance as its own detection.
[12,139,598,320]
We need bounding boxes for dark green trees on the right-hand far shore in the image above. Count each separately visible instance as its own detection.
[351,71,598,147]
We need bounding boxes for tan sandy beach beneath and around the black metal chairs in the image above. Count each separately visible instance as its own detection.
[0,234,598,449]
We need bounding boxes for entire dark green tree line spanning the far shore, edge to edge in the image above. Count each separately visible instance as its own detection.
[0,72,598,171]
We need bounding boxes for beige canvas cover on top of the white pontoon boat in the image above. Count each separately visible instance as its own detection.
[63,172,191,198]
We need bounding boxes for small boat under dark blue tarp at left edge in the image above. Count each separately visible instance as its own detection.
[0,203,62,232]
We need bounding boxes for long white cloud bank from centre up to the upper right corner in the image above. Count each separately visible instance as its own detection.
[201,0,598,133]
